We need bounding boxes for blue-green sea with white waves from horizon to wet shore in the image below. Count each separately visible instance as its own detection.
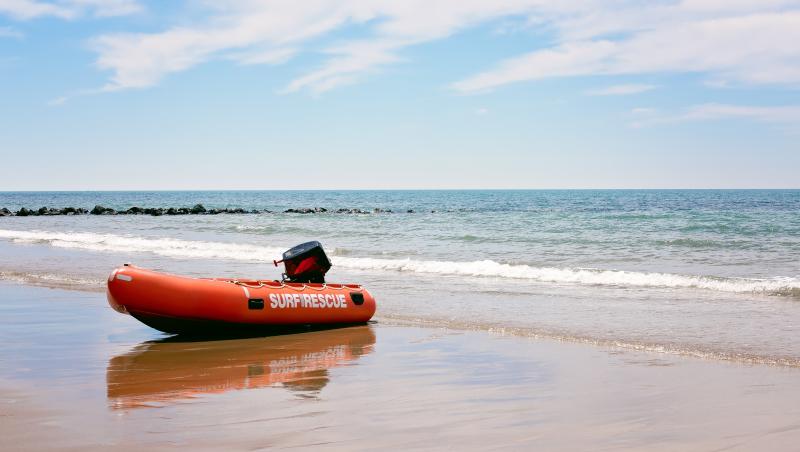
[0,190,800,367]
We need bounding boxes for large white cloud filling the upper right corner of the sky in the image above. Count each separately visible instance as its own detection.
[453,6,800,91]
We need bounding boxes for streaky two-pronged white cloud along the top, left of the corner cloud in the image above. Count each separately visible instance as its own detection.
[90,0,543,92]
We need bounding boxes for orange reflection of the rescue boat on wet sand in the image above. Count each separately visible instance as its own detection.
[106,325,375,409]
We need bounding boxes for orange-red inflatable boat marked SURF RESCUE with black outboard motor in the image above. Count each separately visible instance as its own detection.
[107,242,375,334]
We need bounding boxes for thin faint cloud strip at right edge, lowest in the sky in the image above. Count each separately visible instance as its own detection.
[632,103,800,127]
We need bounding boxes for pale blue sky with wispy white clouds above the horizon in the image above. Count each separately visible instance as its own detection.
[0,0,800,191]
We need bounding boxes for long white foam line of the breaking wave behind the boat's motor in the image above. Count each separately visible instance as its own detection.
[0,230,800,297]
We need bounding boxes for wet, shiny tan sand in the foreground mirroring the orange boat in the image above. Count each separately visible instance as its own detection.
[0,283,800,451]
